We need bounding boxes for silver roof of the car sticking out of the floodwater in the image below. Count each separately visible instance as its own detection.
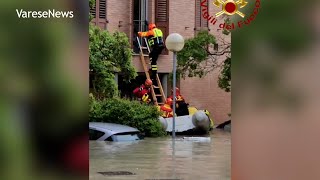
[89,122,139,133]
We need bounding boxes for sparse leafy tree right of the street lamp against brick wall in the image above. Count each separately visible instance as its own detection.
[177,29,231,92]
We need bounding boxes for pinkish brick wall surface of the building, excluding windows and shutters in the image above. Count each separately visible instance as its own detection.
[102,0,231,124]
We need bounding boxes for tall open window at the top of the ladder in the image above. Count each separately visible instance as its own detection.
[133,0,148,53]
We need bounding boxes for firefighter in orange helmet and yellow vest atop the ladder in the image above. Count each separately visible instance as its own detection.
[138,23,164,85]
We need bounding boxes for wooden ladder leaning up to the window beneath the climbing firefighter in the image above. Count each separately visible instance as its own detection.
[137,37,166,106]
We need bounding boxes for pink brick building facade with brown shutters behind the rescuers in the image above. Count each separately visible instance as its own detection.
[91,0,231,124]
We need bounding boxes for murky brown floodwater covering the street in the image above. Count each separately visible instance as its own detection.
[90,130,231,180]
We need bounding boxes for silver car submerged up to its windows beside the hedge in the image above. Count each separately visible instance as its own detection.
[89,122,144,142]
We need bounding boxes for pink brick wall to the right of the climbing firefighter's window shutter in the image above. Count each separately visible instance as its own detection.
[170,0,231,124]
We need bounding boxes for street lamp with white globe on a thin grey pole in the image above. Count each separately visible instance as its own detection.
[166,33,184,139]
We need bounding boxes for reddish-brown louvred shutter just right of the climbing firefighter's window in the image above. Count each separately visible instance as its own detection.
[155,0,169,54]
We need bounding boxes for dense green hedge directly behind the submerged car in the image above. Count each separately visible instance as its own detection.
[89,95,166,137]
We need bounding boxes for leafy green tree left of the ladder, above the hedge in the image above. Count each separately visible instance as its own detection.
[89,25,137,99]
